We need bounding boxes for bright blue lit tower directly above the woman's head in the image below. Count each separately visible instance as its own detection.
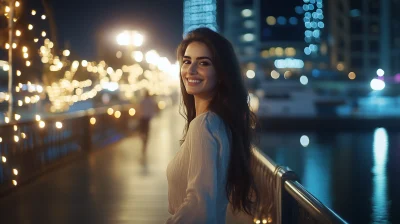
[183,0,218,35]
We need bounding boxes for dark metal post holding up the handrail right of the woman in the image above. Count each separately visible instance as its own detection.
[277,166,298,224]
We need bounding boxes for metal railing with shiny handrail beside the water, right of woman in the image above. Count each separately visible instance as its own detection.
[253,148,347,224]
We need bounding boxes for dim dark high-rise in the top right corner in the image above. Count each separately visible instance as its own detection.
[331,0,400,80]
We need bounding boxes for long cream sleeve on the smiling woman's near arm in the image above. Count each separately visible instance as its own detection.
[166,115,219,224]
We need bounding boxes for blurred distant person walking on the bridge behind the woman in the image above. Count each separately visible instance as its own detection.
[139,90,157,156]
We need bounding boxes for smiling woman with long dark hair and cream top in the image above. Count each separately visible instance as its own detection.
[167,28,259,223]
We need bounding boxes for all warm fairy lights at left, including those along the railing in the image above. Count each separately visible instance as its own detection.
[0,0,179,186]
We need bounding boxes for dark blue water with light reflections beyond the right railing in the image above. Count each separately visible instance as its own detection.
[259,128,400,223]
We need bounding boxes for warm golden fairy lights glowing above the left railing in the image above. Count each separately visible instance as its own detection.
[0,1,178,119]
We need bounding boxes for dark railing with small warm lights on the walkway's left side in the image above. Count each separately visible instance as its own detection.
[0,105,136,195]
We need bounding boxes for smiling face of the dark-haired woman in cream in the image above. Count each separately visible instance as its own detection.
[181,42,217,99]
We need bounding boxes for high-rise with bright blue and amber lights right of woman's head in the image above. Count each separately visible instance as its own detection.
[224,0,330,79]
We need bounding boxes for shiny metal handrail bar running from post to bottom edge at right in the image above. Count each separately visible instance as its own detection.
[285,180,347,224]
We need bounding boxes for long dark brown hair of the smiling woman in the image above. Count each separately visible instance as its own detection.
[177,28,259,214]
